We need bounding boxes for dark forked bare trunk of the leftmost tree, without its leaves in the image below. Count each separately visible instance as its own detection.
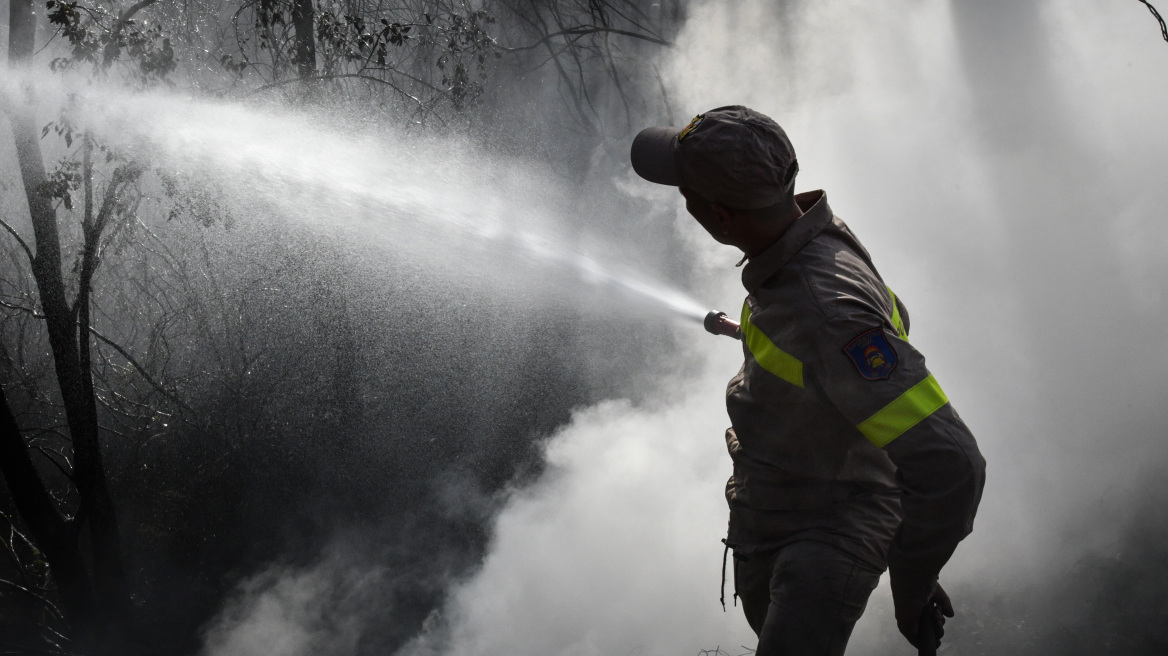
[4,0,130,642]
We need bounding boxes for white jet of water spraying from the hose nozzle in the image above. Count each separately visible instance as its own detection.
[0,71,729,324]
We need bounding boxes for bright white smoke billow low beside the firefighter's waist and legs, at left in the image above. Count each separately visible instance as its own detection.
[394,357,749,656]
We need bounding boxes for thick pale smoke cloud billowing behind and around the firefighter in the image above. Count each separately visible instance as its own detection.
[198,0,1168,656]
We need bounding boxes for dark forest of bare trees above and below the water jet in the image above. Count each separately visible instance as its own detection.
[0,0,683,654]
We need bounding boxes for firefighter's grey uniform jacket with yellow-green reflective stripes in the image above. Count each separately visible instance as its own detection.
[726,191,985,575]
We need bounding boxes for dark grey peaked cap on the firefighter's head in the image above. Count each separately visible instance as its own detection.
[630,105,799,209]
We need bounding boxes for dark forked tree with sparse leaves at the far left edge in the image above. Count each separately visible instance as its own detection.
[0,0,173,650]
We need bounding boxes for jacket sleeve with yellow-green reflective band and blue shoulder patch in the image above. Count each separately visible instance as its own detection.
[815,313,986,580]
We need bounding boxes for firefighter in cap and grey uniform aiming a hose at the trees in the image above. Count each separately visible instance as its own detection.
[631,105,985,656]
